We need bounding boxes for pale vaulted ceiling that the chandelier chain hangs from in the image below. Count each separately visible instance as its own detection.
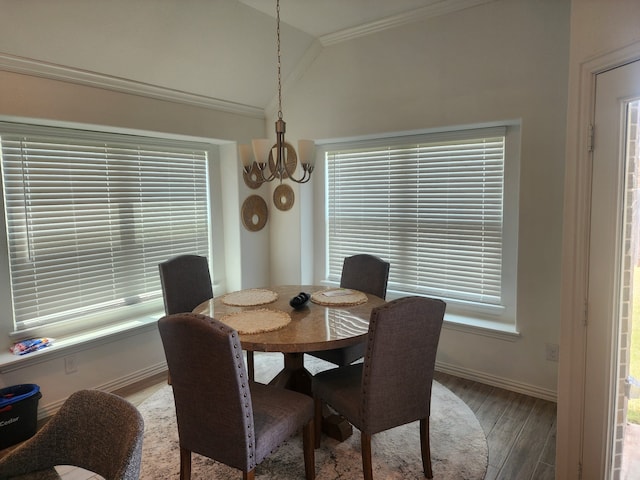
[0,0,492,114]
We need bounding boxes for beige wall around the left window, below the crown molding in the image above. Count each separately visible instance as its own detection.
[0,71,264,416]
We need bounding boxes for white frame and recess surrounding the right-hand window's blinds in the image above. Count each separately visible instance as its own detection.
[314,120,521,334]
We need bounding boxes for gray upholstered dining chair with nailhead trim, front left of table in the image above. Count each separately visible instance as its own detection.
[158,313,315,480]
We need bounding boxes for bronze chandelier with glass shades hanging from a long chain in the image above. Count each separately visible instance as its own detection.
[239,0,315,188]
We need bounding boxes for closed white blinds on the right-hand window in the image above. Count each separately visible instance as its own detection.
[327,128,505,306]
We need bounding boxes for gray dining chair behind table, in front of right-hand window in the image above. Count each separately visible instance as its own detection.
[308,253,390,366]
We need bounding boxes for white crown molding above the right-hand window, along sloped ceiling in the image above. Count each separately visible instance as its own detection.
[319,0,495,47]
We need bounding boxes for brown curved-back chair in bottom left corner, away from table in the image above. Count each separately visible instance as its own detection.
[0,390,144,480]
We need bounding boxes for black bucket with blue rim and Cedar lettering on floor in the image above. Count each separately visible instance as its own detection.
[0,383,42,450]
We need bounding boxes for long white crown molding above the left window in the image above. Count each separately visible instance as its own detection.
[0,52,265,119]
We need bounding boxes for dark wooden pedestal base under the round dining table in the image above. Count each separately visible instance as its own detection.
[269,353,353,442]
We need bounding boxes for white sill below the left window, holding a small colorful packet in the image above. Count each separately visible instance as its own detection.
[0,312,164,374]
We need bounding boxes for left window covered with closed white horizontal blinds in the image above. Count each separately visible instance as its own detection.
[0,124,210,332]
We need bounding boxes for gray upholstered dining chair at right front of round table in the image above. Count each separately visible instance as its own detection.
[312,297,442,480]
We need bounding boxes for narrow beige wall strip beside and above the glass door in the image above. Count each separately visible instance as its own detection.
[556,0,640,478]
